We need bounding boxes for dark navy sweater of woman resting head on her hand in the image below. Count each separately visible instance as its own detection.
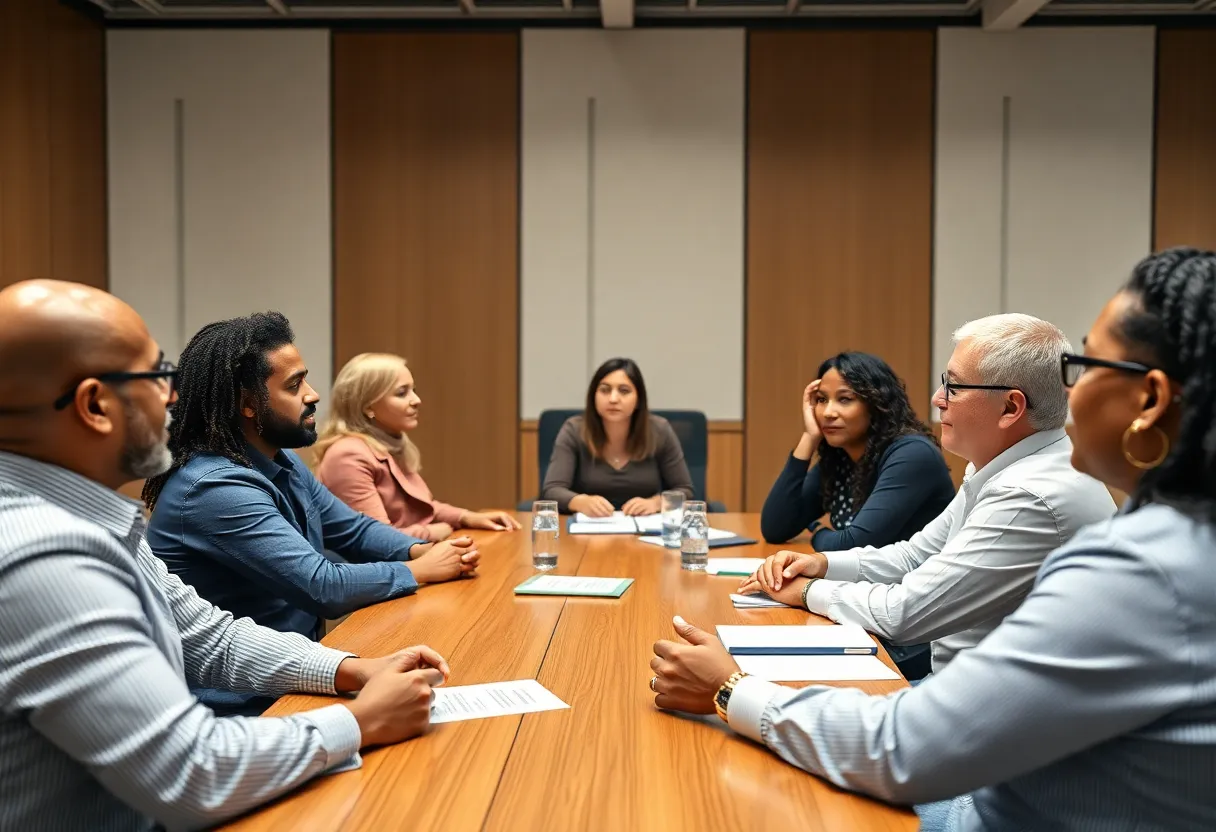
[760,435,955,552]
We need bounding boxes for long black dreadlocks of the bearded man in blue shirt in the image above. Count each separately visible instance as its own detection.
[143,313,295,511]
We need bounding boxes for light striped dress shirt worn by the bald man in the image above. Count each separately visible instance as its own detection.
[0,452,360,832]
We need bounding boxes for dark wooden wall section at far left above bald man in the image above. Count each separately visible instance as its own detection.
[0,0,106,287]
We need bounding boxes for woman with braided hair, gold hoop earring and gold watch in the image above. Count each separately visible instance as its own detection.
[651,248,1216,832]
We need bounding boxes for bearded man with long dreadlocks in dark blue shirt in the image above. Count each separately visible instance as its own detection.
[143,313,480,714]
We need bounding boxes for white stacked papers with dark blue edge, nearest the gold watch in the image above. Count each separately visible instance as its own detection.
[717,624,899,681]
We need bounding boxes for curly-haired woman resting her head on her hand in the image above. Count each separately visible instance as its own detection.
[760,353,955,552]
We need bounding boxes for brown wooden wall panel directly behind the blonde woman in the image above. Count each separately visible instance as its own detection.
[333,32,519,508]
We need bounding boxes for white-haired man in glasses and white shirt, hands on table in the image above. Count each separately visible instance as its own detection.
[741,314,1115,670]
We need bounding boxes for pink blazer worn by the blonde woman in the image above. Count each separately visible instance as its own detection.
[316,437,465,540]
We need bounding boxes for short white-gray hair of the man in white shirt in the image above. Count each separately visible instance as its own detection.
[955,313,1073,431]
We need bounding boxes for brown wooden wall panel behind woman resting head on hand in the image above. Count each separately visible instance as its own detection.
[744,30,934,511]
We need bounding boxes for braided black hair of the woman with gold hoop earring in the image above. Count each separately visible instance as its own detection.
[1115,248,1216,523]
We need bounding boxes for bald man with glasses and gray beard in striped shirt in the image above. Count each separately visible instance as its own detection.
[0,281,447,831]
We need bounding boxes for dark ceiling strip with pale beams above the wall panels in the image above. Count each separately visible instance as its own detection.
[89,0,1216,29]
